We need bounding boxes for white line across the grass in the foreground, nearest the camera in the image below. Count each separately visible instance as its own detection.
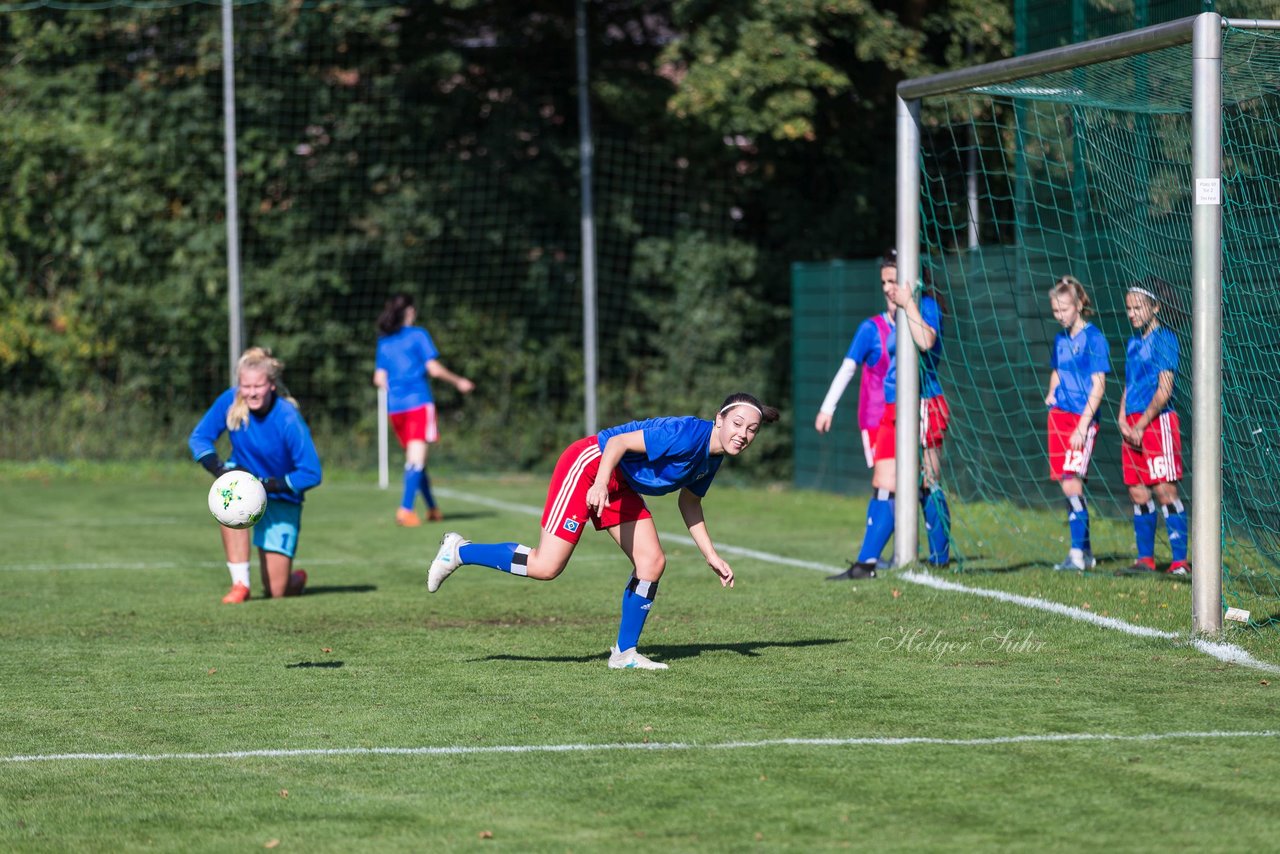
[0,730,1280,763]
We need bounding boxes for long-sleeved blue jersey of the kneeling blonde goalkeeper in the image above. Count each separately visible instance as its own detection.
[187,387,320,504]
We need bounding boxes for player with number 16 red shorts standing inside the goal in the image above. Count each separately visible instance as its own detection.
[1117,278,1187,575]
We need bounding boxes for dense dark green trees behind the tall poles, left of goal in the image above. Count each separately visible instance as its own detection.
[0,0,1011,470]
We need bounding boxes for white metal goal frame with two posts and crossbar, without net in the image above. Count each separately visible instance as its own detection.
[893,13,1280,635]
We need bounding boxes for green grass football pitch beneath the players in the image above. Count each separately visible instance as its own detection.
[0,466,1280,851]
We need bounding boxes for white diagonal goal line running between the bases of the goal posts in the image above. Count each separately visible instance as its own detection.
[435,489,1280,673]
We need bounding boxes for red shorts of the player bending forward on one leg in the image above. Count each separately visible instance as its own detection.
[543,435,653,543]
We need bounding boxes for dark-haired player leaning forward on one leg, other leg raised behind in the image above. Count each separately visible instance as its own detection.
[426,393,778,670]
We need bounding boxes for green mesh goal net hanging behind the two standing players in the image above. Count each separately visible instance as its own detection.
[920,21,1280,622]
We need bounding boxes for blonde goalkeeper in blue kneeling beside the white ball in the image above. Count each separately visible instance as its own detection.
[187,347,320,604]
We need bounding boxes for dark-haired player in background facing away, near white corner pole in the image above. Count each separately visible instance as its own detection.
[374,293,475,528]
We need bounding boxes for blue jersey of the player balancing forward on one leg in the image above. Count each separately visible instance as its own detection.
[596,415,724,497]
